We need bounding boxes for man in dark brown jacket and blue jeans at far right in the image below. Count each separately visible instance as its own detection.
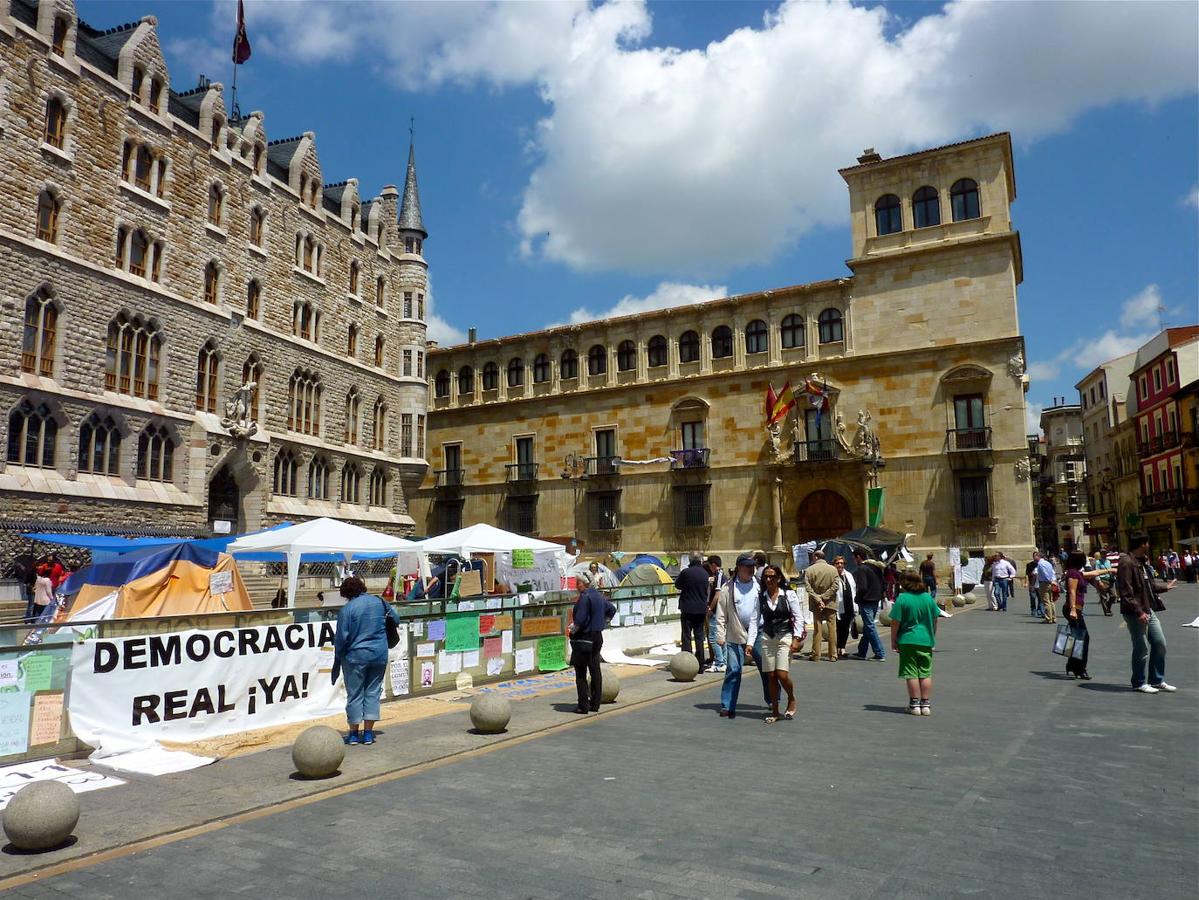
[1116,534,1177,694]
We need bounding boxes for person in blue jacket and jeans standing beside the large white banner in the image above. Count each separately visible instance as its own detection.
[333,575,399,744]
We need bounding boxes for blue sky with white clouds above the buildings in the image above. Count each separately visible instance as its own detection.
[78,0,1199,430]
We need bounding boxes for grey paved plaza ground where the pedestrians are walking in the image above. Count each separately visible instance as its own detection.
[12,586,1199,900]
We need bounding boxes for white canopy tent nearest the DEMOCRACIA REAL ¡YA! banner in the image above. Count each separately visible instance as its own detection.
[228,518,428,606]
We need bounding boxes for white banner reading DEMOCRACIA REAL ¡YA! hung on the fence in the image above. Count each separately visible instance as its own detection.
[68,622,345,759]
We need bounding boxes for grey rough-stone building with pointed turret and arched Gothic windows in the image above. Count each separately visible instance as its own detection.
[0,0,428,548]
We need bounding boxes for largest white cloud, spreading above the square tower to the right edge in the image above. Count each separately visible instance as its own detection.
[173,0,1199,277]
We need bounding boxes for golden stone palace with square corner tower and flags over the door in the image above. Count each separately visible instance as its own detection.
[412,133,1032,557]
